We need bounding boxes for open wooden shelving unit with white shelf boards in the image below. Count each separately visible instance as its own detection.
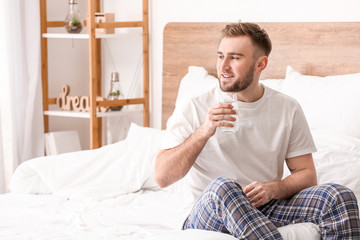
[40,0,150,149]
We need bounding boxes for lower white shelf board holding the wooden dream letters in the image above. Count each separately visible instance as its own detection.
[44,110,143,119]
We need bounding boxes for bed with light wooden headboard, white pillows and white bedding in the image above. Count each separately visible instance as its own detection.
[0,22,360,240]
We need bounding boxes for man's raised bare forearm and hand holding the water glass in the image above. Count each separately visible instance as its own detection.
[155,104,236,187]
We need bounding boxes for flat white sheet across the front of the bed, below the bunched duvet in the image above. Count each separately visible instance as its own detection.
[0,190,319,240]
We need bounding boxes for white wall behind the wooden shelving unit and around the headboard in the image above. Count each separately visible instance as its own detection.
[48,0,360,148]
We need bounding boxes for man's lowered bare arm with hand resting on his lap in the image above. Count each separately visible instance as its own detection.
[243,154,317,207]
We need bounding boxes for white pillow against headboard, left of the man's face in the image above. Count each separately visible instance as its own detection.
[176,66,218,105]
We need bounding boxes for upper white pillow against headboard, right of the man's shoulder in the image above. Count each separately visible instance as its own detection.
[282,66,360,138]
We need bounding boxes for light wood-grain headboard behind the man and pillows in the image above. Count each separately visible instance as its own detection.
[162,22,360,129]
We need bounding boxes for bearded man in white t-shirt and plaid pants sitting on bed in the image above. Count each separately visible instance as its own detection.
[155,23,360,239]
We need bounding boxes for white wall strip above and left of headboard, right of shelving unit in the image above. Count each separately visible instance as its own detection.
[151,0,360,128]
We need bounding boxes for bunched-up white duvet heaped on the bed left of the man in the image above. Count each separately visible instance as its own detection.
[10,124,163,199]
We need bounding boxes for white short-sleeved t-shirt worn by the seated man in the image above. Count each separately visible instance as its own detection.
[162,86,316,199]
